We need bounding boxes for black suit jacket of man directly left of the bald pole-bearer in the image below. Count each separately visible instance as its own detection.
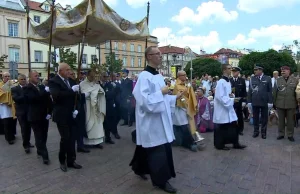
[24,83,52,122]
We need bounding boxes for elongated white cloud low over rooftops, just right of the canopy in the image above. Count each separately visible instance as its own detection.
[152,27,222,53]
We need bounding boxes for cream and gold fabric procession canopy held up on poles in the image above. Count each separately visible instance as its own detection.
[28,0,149,47]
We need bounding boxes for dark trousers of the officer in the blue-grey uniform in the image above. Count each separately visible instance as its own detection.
[253,106,269,135]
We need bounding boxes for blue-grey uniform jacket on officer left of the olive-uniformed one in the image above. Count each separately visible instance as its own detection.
[248,75,273,106]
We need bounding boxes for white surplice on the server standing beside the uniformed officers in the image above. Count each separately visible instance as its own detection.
[213,79,237,124]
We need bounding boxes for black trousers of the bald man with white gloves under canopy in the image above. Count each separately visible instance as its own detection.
[56,122,76,164]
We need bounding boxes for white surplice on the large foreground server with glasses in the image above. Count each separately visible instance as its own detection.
[133,71,176,148]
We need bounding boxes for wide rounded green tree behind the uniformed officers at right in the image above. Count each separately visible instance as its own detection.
[239,49,297,76]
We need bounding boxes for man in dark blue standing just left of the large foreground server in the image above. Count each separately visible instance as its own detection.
[120,69,133,127]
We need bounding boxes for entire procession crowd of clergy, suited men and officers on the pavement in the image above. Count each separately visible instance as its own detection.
[0,47,300,193]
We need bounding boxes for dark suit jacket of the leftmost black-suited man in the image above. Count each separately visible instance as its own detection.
[11,85,28,116]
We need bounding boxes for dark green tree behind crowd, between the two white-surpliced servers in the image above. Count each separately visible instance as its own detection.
[184,58,222,77]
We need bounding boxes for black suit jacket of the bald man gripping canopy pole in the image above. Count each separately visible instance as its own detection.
[48,75,76,124]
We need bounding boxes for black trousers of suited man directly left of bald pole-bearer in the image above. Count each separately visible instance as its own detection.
[30,119,49,159]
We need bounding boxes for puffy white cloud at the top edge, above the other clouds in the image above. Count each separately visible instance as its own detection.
[171,1,238,24]
